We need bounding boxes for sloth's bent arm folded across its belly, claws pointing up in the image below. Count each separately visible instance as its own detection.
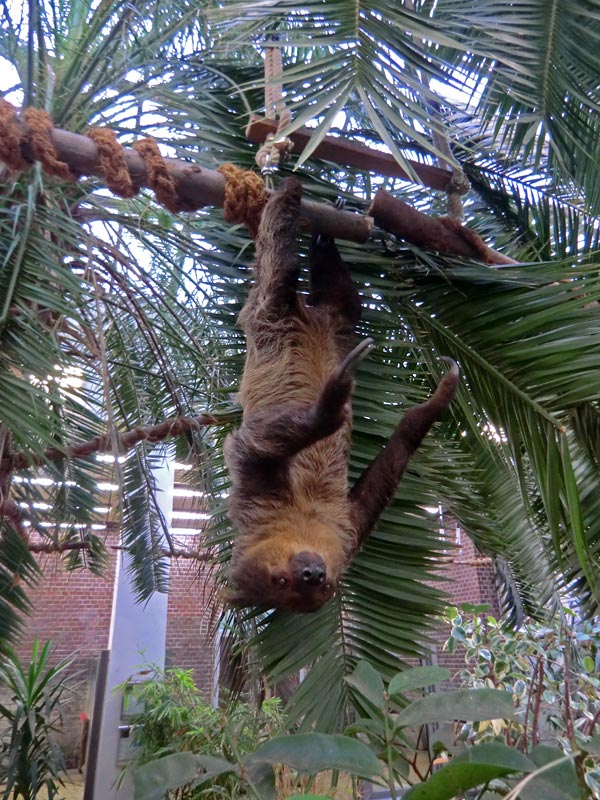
[234,339,373,467]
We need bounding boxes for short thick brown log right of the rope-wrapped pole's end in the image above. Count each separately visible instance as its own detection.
[369,189,518,264]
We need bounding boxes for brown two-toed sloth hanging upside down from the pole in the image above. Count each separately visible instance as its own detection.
[225,178,458,612]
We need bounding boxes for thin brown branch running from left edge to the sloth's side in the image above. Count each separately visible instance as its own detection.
[0,412,237,475]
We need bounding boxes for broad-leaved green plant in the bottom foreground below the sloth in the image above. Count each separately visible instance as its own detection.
[134,662,600,800]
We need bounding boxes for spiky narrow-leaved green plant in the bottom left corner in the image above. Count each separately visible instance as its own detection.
[0,640,72,800]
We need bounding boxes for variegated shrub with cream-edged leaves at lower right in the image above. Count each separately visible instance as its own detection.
[445,604,600,797]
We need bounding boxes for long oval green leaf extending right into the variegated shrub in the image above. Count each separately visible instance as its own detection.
[396,689,517,726]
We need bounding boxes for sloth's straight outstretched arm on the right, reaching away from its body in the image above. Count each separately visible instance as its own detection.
[349,359,458,555]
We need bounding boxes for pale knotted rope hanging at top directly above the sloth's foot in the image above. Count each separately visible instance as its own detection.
[256,38,294,185]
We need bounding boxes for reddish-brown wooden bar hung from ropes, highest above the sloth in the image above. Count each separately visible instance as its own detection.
[246,115,452,191]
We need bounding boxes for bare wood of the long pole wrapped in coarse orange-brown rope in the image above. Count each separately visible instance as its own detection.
[15,120,373,242]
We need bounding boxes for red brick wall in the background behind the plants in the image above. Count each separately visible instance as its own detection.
[9,526,498,762]
